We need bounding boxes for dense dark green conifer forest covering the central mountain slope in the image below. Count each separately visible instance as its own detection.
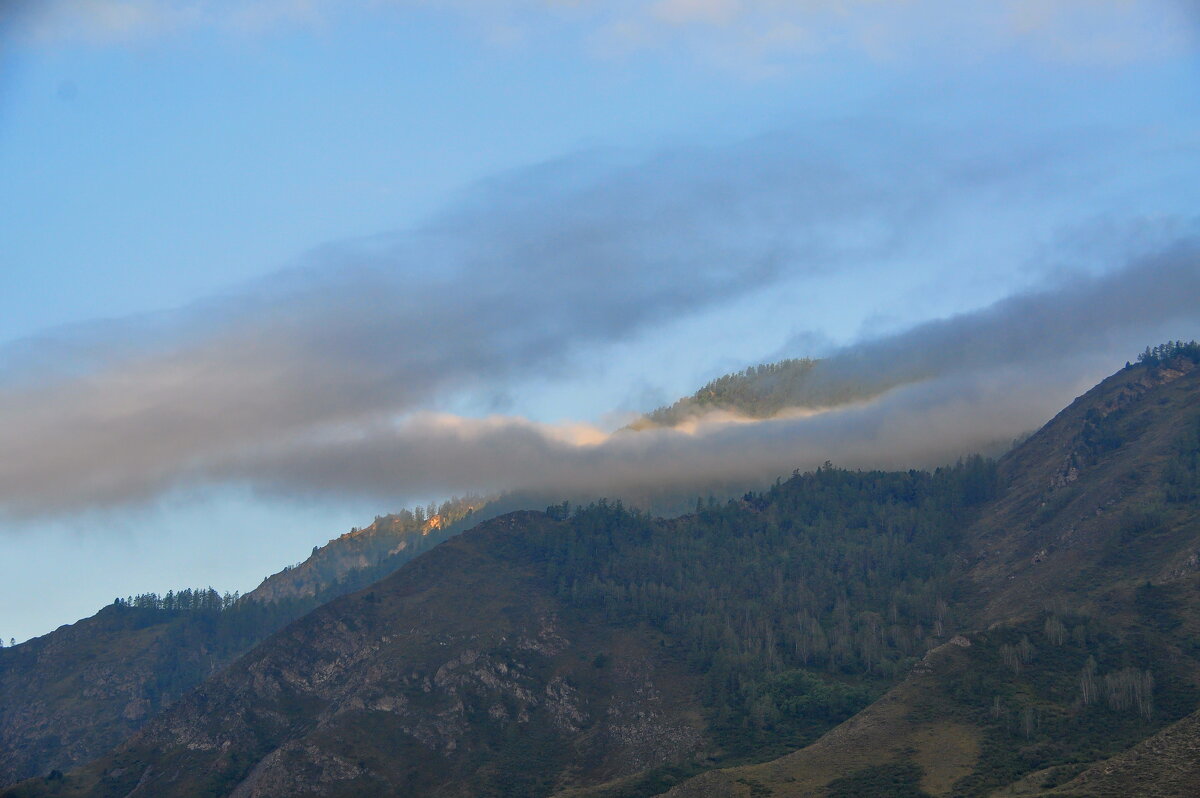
[513,456,997,756]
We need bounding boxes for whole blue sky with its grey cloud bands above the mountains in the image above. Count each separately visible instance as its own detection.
[0,0,1200,641]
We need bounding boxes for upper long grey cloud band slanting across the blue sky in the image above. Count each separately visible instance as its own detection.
[0,137,993,515]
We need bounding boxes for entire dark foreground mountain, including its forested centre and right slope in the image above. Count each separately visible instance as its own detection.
[6,344,1200,798]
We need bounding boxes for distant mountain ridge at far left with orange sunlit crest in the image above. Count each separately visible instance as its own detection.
[0,497,496,784]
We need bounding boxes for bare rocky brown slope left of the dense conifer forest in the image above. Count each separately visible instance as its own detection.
[2,515,698,796]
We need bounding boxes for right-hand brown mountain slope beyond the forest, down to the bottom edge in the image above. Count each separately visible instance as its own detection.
[652,346,1200,798]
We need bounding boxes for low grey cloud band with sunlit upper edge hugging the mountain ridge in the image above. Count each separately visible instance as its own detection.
[212,239,1200,499]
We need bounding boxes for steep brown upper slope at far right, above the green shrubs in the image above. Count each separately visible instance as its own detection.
[964,343,1200,625]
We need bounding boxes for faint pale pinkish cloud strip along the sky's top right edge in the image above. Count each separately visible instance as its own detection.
[606,0,1196,65]
